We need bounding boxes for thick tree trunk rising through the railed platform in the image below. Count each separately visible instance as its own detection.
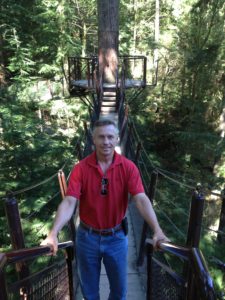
[98,0,119,83]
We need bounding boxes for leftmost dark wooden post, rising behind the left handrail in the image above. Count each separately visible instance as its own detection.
[5,197,29,279]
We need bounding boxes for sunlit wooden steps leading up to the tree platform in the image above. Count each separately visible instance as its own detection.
[100,87,117,116]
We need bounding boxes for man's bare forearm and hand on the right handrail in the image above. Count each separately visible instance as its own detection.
[133,193,169,248]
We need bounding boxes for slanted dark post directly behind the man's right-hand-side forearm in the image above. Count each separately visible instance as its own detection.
[137,171,158,266]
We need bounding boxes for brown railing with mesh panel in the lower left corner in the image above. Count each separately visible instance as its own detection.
[0,241,75,300]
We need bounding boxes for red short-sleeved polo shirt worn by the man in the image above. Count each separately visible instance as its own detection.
[66,152,144,229]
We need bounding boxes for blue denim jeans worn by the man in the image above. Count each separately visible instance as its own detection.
[76,226,128,300]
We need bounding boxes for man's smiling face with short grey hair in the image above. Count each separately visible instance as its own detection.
[93,125,118,156]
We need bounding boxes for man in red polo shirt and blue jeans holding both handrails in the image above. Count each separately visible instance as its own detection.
[42,119,168,300]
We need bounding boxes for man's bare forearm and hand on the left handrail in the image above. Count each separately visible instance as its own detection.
[41,196,77,254]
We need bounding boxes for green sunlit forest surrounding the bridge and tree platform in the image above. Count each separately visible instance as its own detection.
[0,0,225,297]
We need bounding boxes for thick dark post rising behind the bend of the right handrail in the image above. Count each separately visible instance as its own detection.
[184,187,205,300]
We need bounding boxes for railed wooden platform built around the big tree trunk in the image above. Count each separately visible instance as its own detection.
[68,56,147,97]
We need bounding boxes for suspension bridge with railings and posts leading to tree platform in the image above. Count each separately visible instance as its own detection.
[0,56,225,300]
